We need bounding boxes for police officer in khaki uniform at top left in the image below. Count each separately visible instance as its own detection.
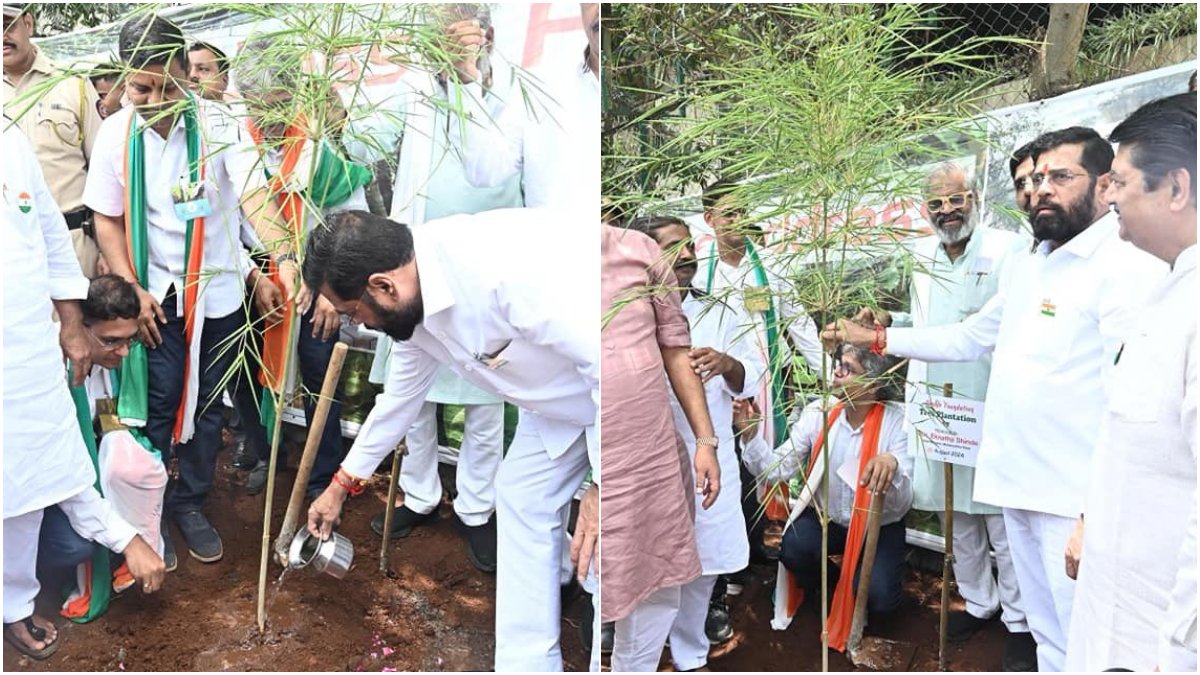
[4,2,101,279]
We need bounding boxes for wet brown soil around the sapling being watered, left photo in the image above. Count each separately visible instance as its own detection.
[4,444,588,671]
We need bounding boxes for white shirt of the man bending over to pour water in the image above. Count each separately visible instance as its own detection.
[342,209,600,476]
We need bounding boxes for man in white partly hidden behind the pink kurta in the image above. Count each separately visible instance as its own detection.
[630,217,767,671]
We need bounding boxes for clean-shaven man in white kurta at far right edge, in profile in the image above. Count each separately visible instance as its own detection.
[1067,95,1200,673]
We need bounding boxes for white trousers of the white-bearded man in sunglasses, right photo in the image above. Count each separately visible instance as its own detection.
[937,510,1030,633]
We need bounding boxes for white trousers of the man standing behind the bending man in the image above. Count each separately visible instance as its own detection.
[400,401,504,527]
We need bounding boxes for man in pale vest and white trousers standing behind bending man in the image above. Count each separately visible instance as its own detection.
[348,5,522,564]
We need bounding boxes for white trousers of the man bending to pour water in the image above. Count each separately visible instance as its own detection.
[496,417,588,671]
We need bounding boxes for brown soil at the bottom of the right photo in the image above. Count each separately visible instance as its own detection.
[665,557,1006,671]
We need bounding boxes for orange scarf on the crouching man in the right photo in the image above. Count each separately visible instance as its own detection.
[805,401,884,652]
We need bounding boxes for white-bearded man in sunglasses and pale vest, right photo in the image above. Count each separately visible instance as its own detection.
[864,162,1037,671]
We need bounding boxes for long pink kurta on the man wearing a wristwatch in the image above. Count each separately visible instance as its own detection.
[600,226,701,670]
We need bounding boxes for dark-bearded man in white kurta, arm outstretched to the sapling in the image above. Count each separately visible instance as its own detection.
[824,127,1165,671]
